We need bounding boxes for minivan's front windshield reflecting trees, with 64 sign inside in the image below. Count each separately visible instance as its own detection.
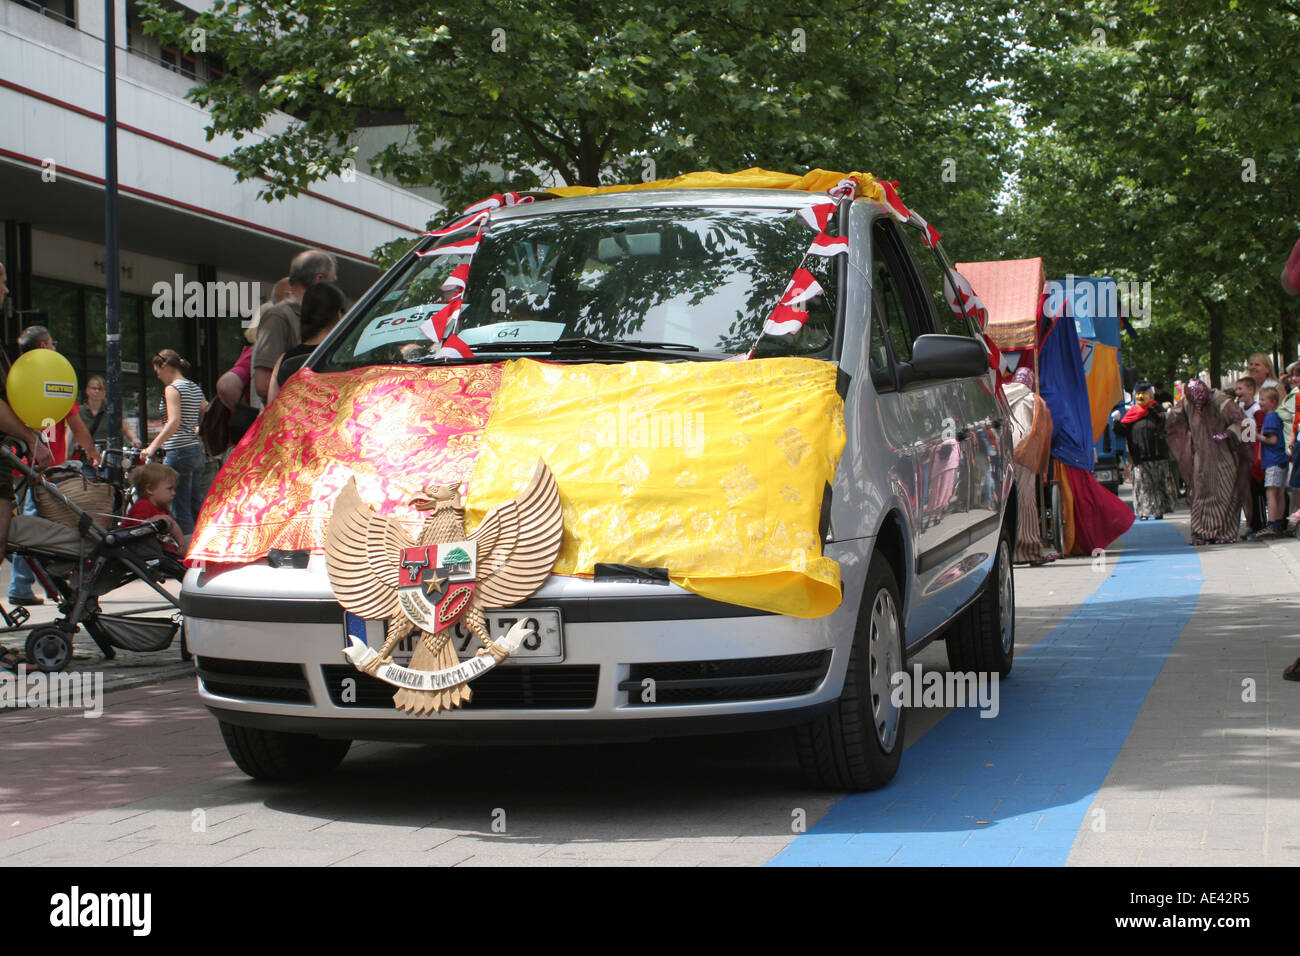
[317,207,836,371]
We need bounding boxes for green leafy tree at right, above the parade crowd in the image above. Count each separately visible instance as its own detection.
[1004,0,1300,385]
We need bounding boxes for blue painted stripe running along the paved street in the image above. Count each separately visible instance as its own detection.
[768,522,1203,866]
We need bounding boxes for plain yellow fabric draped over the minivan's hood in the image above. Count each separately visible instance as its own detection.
[465,358,845,618]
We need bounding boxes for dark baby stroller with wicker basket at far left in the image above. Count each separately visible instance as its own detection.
[0,445,189,672]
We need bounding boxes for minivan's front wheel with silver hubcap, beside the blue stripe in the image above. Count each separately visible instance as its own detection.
[794,554,907,791]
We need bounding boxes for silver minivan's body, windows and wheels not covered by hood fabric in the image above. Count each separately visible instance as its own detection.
[181,189,1017,790]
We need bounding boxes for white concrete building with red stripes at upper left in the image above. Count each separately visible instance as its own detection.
[0,0,442,433]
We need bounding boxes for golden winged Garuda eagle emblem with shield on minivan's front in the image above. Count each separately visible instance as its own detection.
[325,460,564,714]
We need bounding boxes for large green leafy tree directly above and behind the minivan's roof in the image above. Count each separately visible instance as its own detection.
[142,0,1014,258]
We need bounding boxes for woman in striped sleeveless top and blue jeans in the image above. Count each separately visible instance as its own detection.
[140,349,208,535]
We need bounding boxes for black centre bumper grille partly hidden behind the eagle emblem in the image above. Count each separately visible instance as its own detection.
[321,663,601,710]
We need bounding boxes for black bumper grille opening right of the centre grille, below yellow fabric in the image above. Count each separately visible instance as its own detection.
[619,650,831,706]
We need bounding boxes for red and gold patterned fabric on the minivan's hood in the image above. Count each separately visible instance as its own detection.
[186,364,502,566]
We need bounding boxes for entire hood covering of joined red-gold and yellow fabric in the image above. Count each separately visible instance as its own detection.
[187,358,845,617]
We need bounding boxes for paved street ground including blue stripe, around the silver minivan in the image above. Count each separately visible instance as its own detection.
[0,511,1300,866]
